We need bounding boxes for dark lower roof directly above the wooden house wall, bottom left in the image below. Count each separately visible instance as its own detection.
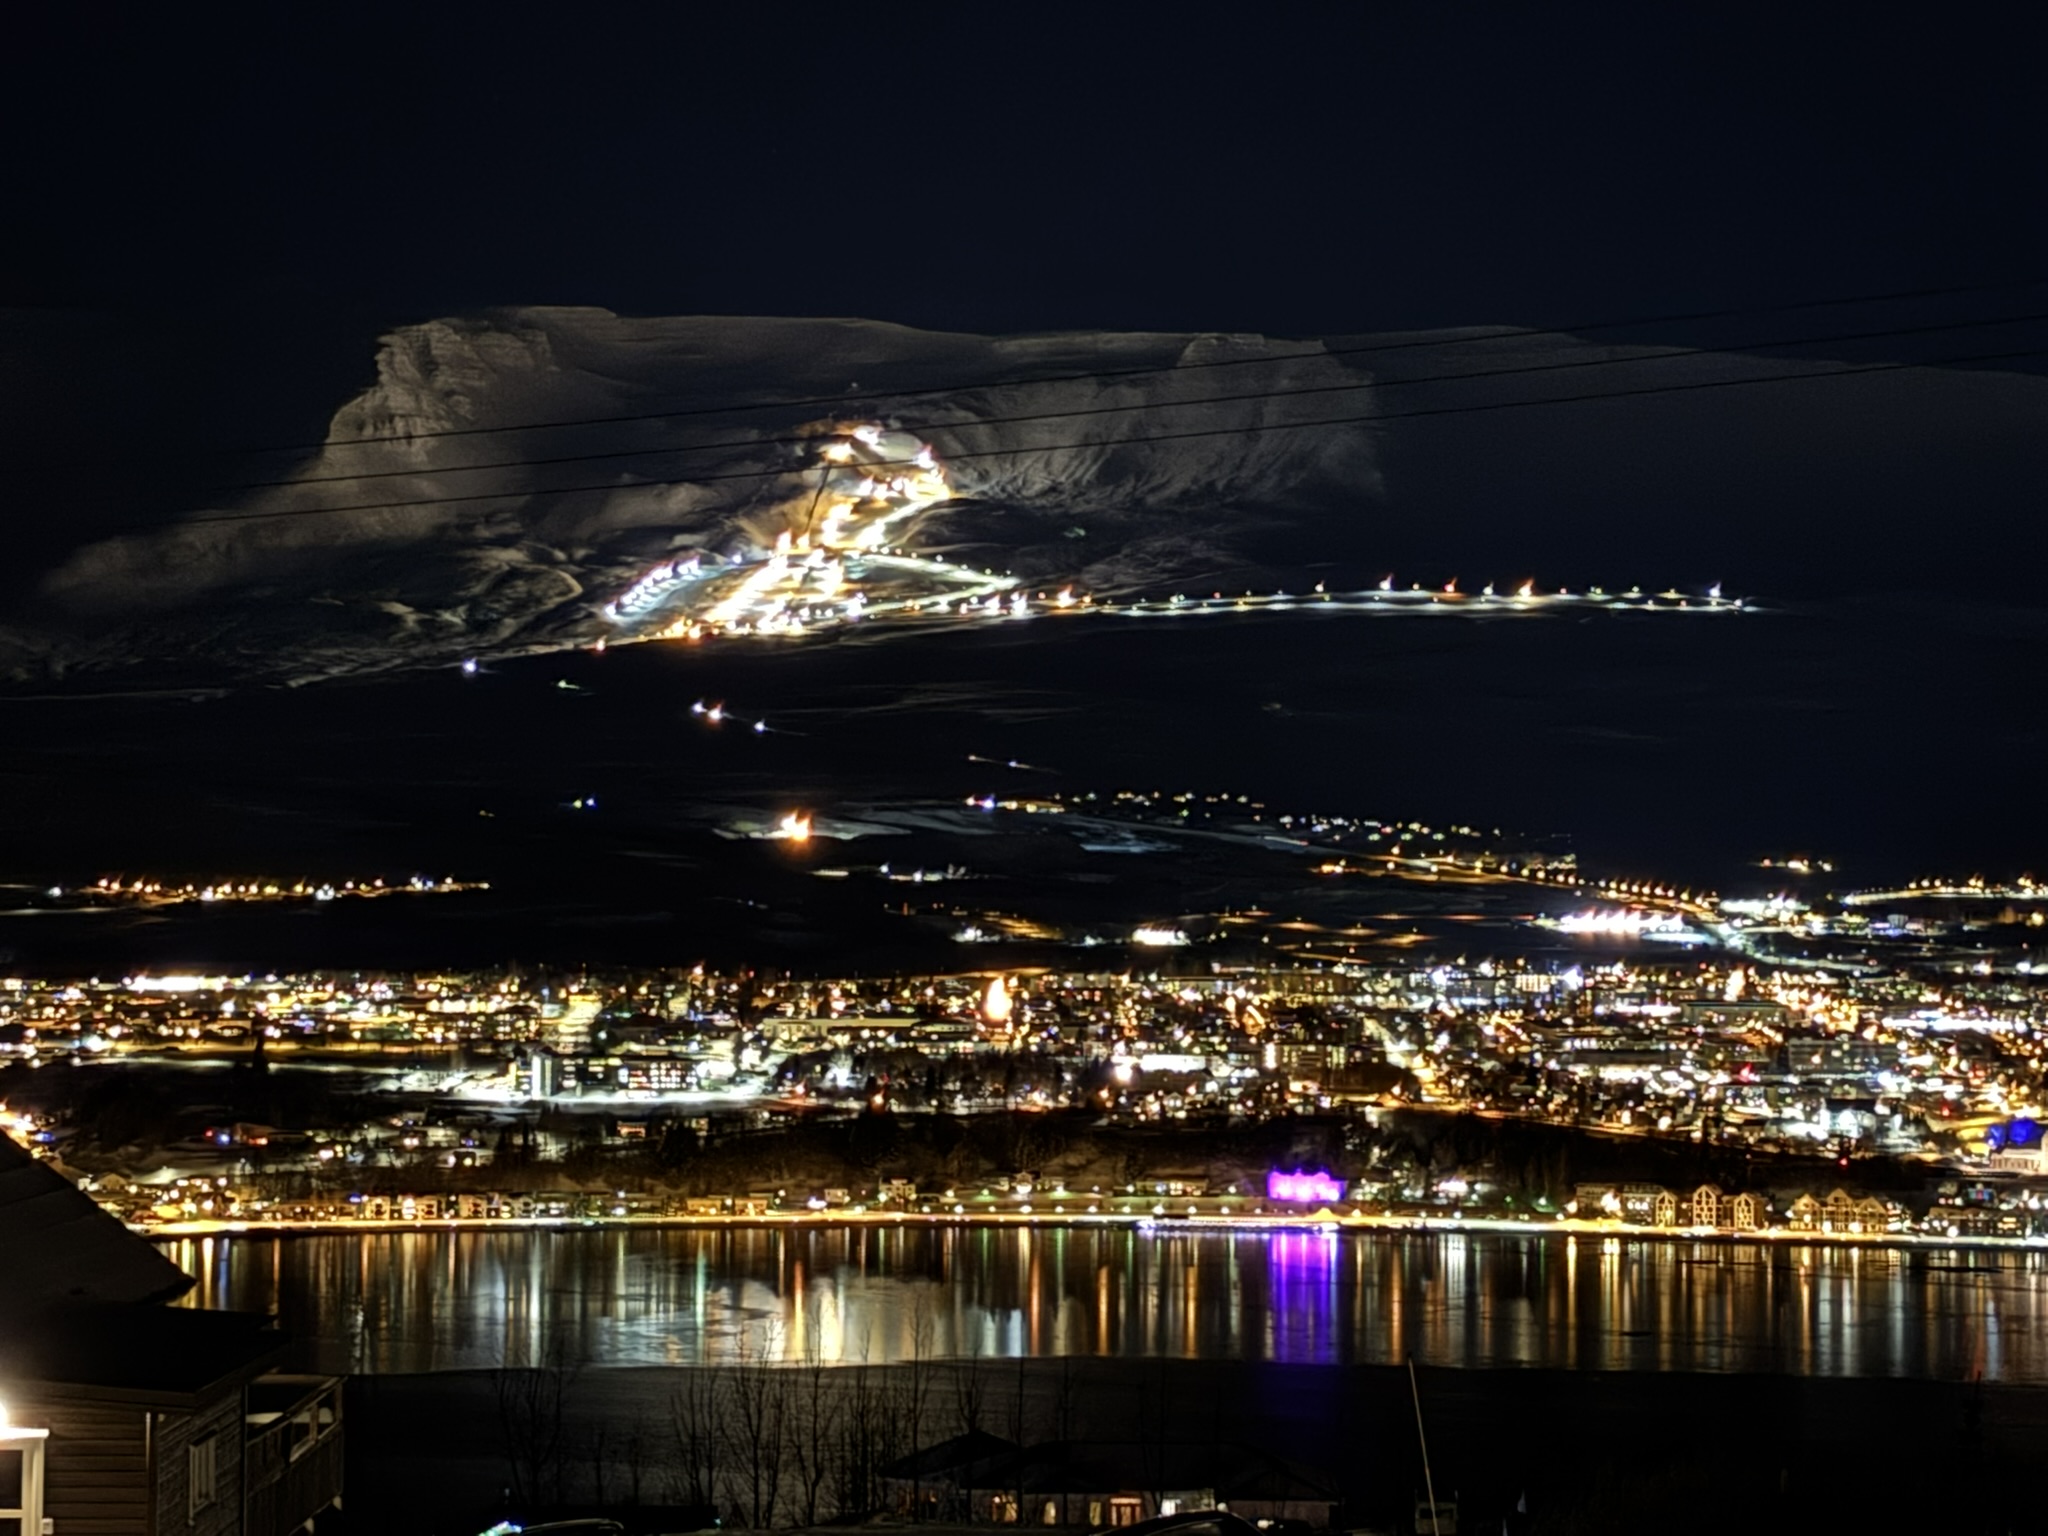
[0,1303,285,1407]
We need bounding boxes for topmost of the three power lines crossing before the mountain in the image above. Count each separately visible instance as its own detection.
[223,279,2048,457]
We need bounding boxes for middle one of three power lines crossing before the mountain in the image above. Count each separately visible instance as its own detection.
[203,309,2048,496]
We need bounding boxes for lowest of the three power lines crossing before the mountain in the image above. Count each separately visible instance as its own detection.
[167,346,2048,532]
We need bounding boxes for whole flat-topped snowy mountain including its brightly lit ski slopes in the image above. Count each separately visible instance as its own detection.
[16,307,2048,690]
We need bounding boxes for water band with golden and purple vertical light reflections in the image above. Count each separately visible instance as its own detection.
[170,1225,2048,1382]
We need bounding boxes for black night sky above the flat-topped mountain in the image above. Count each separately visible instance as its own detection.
[16,4,2048,334]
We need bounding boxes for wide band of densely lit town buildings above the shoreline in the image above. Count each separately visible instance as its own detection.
[0,952,2048,1233]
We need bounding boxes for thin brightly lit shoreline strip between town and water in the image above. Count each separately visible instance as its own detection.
[129,1210,2048,1253]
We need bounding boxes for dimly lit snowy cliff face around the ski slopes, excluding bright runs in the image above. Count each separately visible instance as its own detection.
[16,309,1376,680]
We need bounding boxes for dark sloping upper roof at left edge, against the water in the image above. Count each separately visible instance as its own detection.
[0,1137,193,1317]
